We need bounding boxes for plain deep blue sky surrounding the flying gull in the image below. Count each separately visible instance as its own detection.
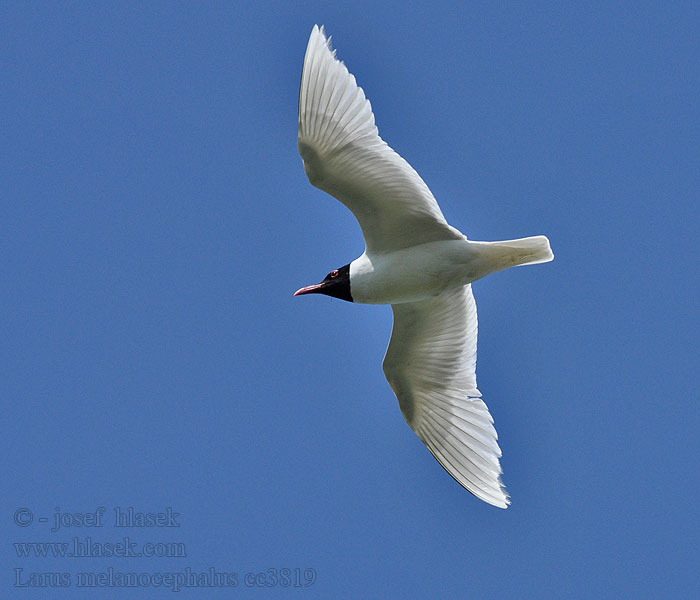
[0,2,700,599]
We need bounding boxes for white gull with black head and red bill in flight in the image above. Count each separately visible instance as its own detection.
[294,26,554,508]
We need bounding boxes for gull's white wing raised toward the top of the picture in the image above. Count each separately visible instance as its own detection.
[298,26,464,253]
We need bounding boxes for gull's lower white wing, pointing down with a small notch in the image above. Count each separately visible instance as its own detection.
[384,285,510,508]
